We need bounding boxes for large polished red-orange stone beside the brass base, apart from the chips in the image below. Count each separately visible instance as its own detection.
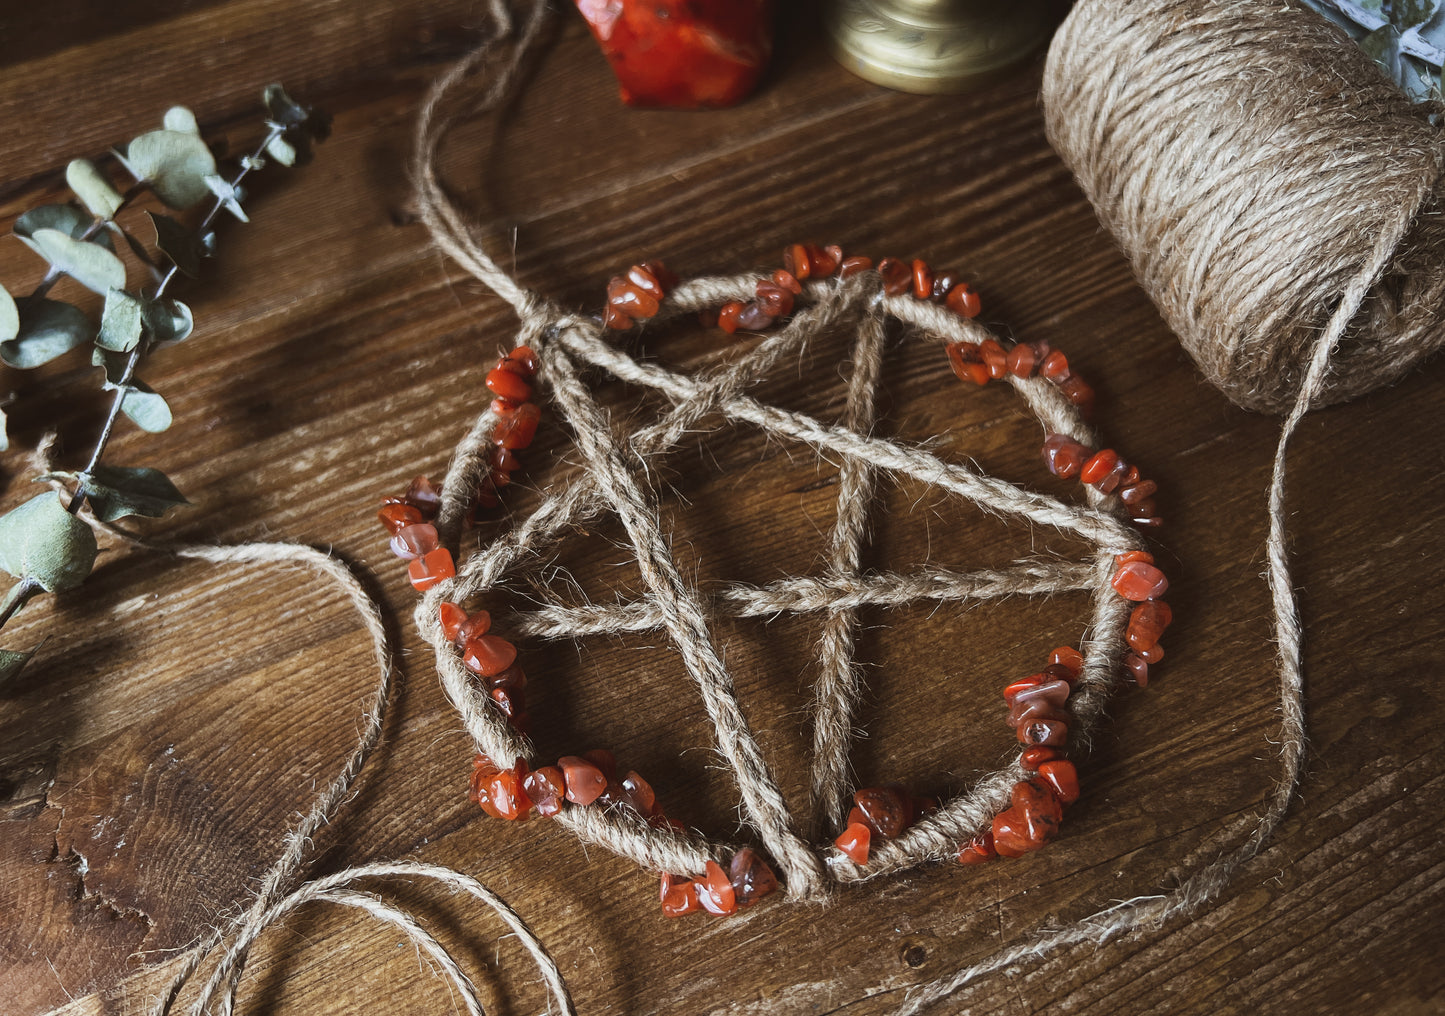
[575,0,772,110]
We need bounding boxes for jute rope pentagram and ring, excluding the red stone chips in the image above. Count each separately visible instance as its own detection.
[416,276,1143,897]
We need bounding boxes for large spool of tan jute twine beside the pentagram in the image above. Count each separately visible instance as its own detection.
[1043,0,1445,412]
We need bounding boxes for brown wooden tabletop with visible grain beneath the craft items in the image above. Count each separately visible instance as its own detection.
[0,0,1445,1016]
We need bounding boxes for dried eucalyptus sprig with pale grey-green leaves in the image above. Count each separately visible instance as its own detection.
[0,85,329,681]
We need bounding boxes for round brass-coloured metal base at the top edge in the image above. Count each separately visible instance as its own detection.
[825,0,1055,92]
